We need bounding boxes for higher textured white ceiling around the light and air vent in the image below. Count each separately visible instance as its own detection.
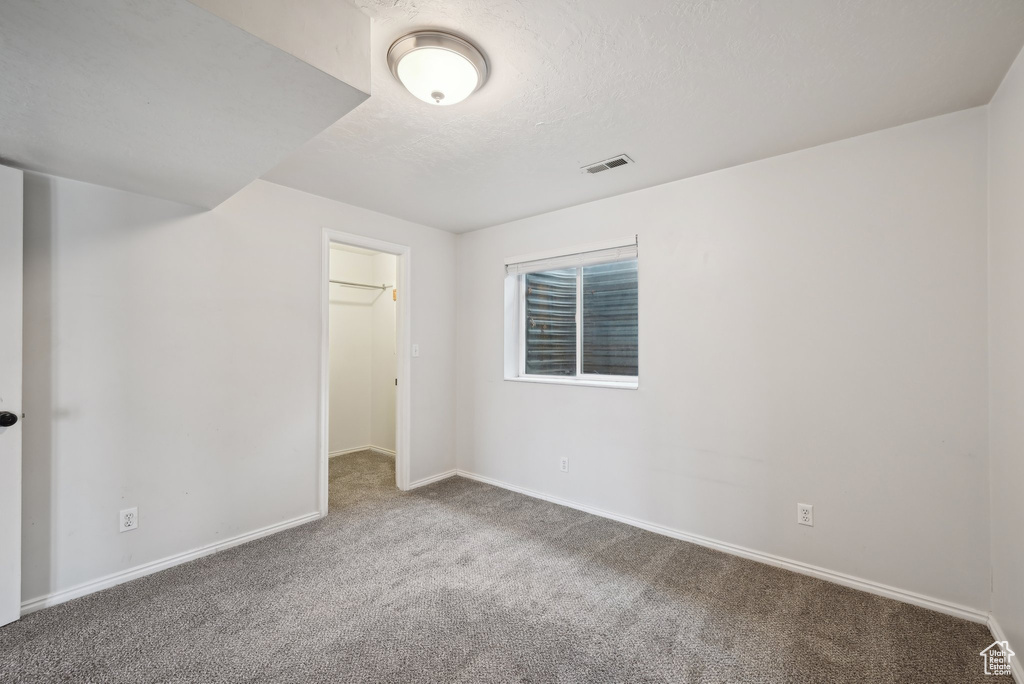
[265,0,1024,231]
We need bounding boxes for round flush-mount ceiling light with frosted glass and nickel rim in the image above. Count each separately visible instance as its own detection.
[387,31,487,104]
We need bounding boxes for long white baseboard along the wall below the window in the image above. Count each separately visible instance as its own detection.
[458,470,989,624]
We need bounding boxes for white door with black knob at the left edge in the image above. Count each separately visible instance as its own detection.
[0,166,24,625]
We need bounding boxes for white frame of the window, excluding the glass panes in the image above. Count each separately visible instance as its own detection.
[505,236,640,389]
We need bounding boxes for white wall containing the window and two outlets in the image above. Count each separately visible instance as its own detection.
[457,109,991,610]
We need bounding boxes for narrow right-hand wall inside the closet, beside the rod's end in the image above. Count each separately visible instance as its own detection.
[370,254,398,452]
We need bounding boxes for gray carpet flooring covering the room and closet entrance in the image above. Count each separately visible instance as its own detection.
[0,453,993,684]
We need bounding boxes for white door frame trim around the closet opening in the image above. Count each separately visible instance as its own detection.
[317,227,413,516]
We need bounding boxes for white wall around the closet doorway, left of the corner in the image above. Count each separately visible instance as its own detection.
[23,174,455,599]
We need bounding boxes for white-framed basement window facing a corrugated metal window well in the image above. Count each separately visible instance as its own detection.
[506,238,639,387]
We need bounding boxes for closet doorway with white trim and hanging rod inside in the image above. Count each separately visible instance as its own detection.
[319,230,411,515]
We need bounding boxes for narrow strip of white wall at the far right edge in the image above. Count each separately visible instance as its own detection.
[988,45,1024,657]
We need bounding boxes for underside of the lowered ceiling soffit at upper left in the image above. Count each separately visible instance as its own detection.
[0,0,370,207]
